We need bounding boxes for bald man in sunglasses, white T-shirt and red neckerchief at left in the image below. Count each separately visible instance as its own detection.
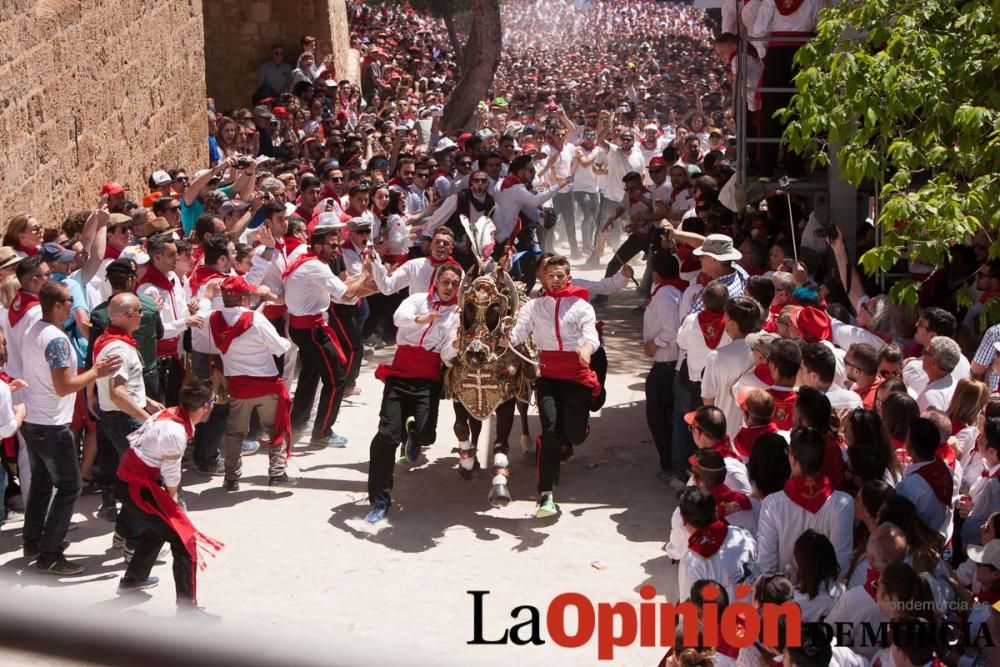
[94,292,163,563]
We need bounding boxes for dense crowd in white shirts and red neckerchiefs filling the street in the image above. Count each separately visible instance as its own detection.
[0,0,1000,667]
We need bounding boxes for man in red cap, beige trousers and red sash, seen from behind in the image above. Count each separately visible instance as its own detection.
[208,276,296,491]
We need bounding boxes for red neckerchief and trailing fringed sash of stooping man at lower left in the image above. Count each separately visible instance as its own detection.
[118,448,223,598]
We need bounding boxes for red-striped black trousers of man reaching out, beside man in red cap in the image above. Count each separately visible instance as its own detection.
[288,327,345,438]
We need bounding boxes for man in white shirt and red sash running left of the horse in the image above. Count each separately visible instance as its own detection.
[365,264,462,524]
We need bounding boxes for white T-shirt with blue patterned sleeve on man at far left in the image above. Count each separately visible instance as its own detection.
[18,320,77,426]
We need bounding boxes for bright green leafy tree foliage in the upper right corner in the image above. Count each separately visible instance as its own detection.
[784,0,1000,303]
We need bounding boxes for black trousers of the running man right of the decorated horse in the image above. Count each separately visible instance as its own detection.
[535,378,591,493]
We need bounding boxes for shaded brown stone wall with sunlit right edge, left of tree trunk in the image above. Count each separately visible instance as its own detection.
[204,0,357,111]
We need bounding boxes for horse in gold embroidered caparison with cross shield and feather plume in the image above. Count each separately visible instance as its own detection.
[444,219,538,507]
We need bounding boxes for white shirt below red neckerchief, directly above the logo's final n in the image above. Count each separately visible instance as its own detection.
[757,491,854,581]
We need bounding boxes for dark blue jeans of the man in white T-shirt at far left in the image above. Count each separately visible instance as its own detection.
[21,422,83,560]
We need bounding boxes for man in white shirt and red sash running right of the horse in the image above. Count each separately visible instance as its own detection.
[509,255,601,517]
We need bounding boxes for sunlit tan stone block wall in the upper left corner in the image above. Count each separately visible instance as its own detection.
[0,0,208,226]
